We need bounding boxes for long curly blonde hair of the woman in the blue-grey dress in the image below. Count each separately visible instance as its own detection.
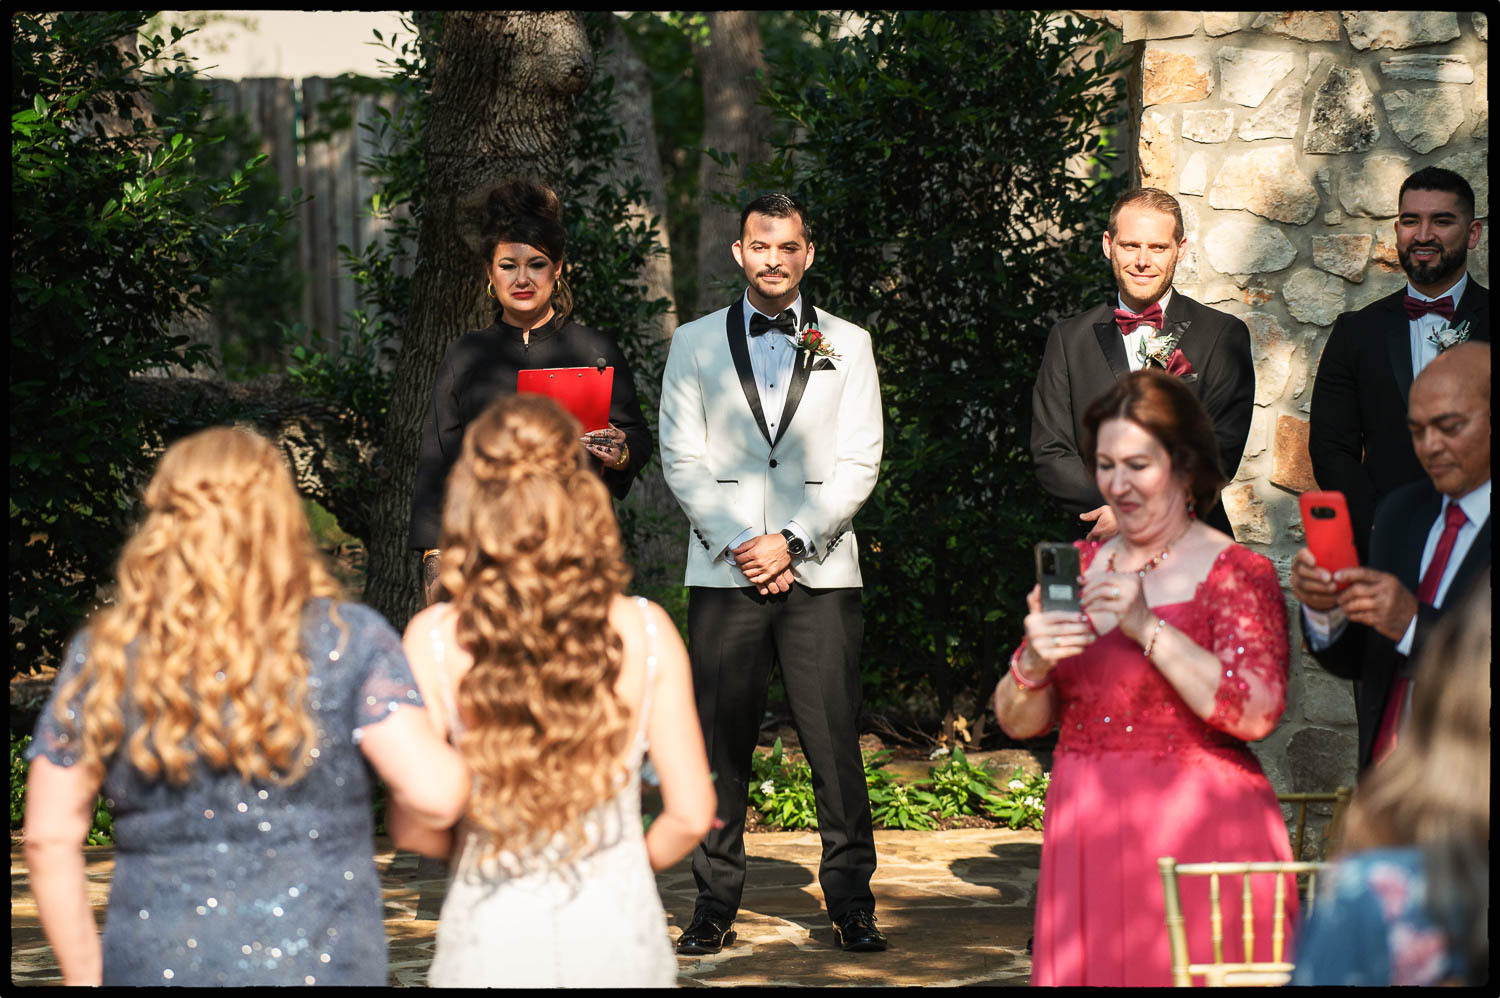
[57,426,342,785]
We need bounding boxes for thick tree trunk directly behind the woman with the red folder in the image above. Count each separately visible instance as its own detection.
[365,11,594,629]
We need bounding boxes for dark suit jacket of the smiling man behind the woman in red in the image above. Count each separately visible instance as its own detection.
[1031,291,1256,537]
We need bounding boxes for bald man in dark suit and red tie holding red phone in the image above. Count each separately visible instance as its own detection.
[1292,342,1493,779]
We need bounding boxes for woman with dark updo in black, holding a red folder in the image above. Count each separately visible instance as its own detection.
[408,180,653,602]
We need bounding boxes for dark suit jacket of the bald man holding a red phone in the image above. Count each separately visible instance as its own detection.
[1298,476,1491,770]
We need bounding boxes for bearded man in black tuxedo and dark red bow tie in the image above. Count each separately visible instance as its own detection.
[1308,167,1490,558]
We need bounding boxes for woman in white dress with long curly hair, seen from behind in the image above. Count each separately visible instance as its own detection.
[405,395,716,987]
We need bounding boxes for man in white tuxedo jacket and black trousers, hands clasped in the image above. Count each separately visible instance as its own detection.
[660,194,885,954]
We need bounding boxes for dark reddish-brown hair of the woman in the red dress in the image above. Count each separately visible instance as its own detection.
[1083,368,1229,518]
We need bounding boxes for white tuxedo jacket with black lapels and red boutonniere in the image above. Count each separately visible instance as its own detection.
[660,294,885,588]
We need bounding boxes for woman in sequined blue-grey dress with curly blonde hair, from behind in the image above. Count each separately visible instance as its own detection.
[26,428,468,984]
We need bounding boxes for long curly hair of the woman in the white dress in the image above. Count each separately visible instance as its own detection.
[440,395,630,855]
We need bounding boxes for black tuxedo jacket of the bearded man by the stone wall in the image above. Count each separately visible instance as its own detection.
[1308,282,1490,561]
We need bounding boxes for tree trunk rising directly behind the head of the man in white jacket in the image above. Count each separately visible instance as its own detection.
[693,11,771,315]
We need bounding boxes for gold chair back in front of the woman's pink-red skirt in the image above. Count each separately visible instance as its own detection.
[1157,855,1329,987]
